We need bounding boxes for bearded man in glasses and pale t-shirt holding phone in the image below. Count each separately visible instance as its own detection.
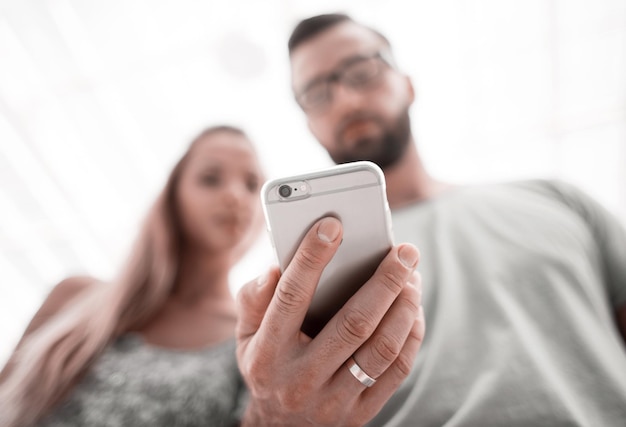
[238,11,626,426]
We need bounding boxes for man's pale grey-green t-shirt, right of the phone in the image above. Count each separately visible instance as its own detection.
[371,181,626,427]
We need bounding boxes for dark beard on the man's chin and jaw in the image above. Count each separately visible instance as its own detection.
[328,108,411,170]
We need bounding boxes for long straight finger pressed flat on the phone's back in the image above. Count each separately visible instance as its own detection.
[264,217,343,344]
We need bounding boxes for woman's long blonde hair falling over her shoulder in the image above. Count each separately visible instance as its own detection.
[0,126,245,427]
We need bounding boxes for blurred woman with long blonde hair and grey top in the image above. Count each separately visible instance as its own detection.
[0,126,263,427]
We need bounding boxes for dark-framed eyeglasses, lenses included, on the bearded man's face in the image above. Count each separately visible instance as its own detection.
[296,52,391,112]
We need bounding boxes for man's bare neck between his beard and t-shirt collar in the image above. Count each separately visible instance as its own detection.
[385,139,449,209]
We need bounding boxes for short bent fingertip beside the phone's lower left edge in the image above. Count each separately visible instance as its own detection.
[235,267,280,341]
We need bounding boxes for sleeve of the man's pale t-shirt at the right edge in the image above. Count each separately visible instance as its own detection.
[547,180,626,308]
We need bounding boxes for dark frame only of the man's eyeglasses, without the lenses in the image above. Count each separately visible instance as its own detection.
[294,50,396,113]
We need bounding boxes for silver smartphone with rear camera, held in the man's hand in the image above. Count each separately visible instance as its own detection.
[261,161,393,337]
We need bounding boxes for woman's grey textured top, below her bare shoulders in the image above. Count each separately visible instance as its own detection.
[37,334,247,427]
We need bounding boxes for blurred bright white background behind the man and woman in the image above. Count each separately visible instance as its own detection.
[0,0,626,363]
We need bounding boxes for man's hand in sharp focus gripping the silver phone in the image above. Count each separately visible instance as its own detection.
[237,218,424,426]
